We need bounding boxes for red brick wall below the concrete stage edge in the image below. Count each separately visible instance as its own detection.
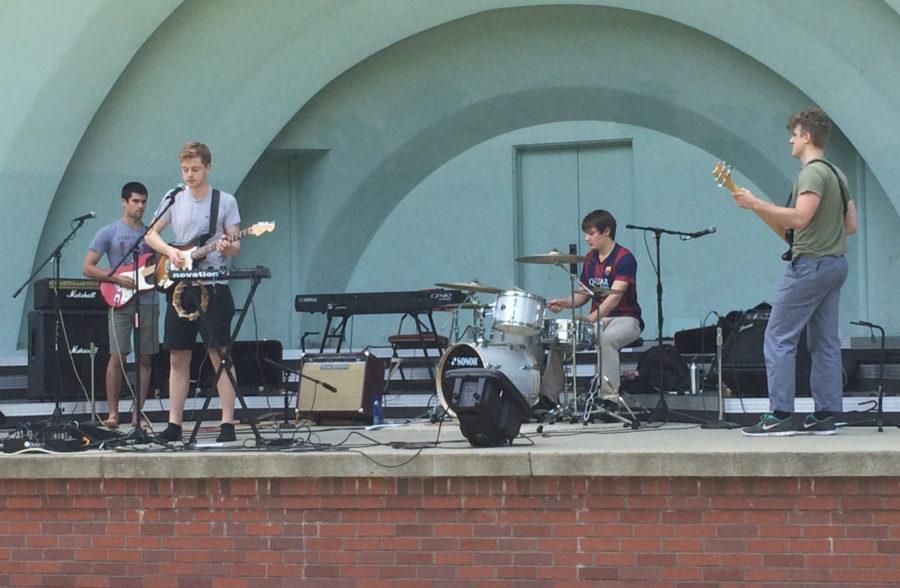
[0,478,900,588]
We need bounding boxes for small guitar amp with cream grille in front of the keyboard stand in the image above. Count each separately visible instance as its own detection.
[297,353,384,423]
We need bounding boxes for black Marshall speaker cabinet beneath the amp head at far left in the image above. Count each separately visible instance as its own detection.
[28,310,109,400]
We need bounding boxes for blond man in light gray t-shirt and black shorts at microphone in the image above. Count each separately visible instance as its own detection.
[146,143,241,443]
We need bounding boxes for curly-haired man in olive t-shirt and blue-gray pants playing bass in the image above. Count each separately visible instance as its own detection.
[733,108,856,436]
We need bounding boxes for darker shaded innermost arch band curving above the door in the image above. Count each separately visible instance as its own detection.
[309,88,790,291]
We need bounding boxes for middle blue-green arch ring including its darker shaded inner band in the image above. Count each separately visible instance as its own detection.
[273,8,849,290]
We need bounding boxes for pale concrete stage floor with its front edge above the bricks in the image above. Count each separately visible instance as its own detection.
[0,422,900,479]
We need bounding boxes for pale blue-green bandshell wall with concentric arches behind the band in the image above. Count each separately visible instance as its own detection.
[0,0,900,350]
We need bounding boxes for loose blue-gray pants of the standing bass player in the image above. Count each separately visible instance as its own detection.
[763,256,847,412]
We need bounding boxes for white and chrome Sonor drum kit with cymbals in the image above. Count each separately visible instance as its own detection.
[435,250,637,427]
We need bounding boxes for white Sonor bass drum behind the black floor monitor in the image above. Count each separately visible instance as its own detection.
[436,342,541,416]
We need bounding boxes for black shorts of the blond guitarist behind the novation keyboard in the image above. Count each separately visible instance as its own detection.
[163,284,234,350]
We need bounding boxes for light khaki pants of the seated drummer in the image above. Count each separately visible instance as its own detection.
[541,316,641,402]
